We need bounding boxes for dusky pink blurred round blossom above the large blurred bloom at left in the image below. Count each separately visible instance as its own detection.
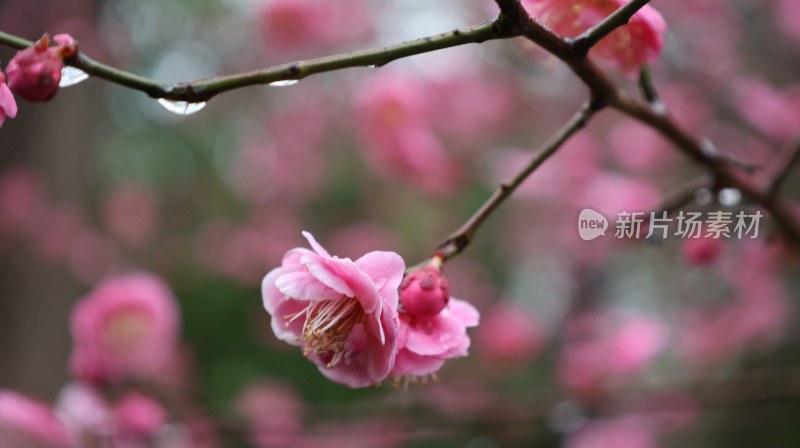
[103,184,158,248]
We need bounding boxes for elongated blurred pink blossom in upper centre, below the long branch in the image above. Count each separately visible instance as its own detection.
[356,72,458,194]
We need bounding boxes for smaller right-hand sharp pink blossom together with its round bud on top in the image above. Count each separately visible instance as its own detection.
[392,259,480,381]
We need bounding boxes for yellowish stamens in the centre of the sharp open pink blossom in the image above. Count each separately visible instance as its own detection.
[284,297,366,368]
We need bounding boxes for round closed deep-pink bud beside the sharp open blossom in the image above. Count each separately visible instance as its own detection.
[400,266,450,319]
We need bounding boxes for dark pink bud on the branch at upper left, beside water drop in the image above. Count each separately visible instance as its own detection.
[6,34,64,103]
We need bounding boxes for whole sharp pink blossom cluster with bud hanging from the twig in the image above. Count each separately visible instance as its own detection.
[262,232,479,387]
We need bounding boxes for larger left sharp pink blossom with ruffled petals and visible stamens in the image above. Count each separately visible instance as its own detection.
[261,232,405,387]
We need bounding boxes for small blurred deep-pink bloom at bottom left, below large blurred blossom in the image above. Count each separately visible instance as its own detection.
[114,392,167,439]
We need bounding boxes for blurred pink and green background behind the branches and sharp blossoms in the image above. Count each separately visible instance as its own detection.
[0,0,800,447]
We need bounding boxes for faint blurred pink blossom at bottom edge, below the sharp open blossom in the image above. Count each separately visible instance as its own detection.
[236,381,303,448]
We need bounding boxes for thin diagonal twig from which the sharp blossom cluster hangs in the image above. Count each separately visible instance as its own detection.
[437,103,596,261]
